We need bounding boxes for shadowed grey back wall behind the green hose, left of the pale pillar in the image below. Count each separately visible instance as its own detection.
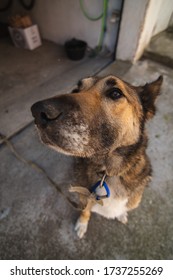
[0,0,122,51]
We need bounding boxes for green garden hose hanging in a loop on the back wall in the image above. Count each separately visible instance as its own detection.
[79,0,108,55]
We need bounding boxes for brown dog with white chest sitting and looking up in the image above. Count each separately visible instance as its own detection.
[31,76,163,238]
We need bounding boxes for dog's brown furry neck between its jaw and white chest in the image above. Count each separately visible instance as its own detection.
[78,135,147,187]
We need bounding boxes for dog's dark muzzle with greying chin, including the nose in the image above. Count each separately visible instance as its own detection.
[31,94,94,156]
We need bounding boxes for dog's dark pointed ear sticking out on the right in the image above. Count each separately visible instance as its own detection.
[137,76,163,119]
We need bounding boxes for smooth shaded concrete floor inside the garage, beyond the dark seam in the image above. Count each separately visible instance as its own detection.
[0,38,111,140]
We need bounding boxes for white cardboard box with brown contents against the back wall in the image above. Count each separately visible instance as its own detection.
[8,24,42,50]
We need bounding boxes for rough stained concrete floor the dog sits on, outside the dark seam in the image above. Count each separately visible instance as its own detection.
[0,40,173,259]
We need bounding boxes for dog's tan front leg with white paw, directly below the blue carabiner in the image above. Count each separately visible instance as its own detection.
[75,209,91,238]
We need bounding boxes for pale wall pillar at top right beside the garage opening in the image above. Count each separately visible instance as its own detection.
[117,0,173,62]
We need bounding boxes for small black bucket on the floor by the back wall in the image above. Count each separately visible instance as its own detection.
[65,39,87,60]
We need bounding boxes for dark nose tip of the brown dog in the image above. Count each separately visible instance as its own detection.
[31,101,62,125]
